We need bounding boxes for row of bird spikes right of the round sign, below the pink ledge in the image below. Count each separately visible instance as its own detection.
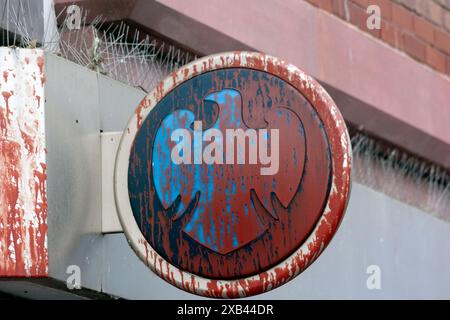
[351,132,450,221]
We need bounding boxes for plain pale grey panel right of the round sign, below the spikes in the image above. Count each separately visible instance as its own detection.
[274,183,450,299]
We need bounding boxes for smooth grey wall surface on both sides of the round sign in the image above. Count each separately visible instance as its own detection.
[46,55,450,299]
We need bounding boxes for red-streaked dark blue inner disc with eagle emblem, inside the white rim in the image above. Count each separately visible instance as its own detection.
[128,68,331,279]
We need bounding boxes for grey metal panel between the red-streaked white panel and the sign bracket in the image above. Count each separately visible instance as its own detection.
[45,54,101,290]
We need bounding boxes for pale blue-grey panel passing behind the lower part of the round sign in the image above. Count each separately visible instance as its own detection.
[99,183,450,299]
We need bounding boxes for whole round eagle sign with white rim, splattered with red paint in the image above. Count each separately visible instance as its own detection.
[114,52,351,298]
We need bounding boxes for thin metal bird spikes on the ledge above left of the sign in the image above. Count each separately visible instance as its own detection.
[0,0,196,91]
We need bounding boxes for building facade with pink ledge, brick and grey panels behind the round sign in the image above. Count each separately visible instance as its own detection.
[0,0,450,299]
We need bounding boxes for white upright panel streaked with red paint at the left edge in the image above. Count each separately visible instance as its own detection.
[0,48,48,277]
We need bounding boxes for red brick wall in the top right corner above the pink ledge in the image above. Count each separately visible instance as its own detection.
[306,0,450,75]
